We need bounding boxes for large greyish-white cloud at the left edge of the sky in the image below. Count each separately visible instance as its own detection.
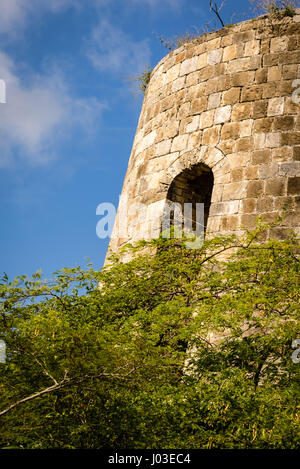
[0,52,106,166]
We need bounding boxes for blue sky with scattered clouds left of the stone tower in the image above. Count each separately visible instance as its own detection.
[0,0,255,277]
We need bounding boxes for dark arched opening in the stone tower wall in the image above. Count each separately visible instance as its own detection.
[163,163,214,238]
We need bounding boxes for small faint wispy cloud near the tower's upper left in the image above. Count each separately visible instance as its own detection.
[87,20,151,77]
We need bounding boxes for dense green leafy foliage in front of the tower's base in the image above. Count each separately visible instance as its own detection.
[0,226,300,449]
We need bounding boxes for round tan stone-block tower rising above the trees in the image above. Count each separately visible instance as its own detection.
[109,10,300,260]
